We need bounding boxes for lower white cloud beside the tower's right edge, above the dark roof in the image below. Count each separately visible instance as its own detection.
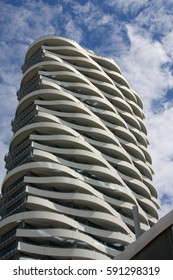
[147,106,173,212]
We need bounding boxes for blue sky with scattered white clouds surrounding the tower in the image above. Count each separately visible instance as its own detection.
[0,0,173,216]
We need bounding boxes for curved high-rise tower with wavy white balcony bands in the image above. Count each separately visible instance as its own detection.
[0,36,159,259]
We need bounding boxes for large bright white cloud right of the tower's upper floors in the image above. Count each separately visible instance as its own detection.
[116,25,173,110]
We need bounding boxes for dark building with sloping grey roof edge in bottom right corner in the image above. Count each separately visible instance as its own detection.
[115,210,173,260]
